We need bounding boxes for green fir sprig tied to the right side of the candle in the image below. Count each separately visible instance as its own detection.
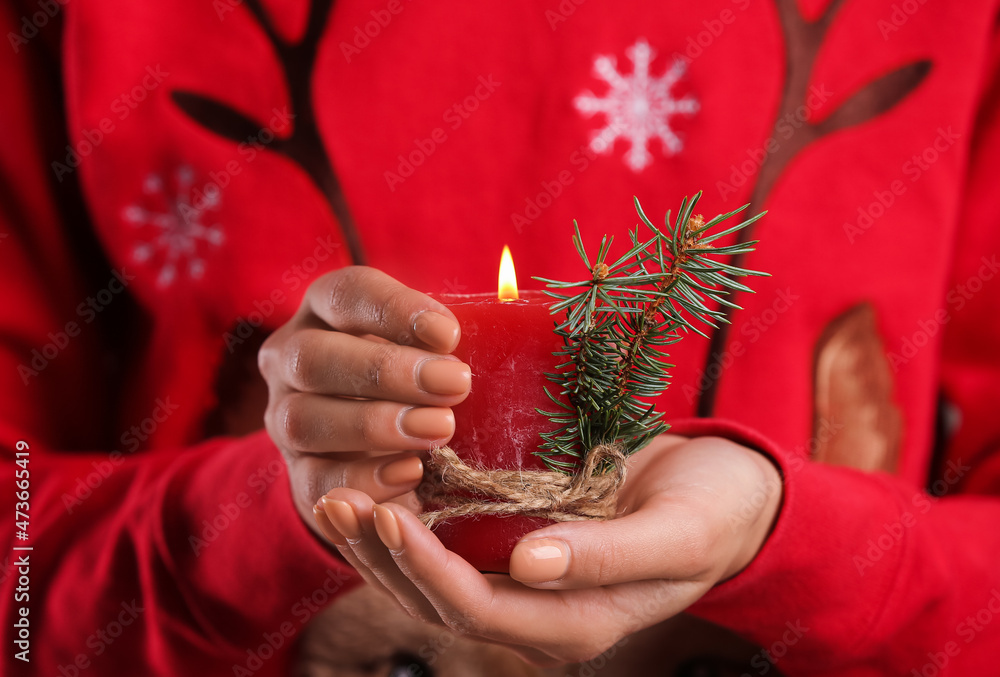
[535,193,766,474]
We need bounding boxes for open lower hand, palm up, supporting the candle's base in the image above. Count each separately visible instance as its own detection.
[317,436,782,664]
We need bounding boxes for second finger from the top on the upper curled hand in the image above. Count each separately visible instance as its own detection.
[280,329,472,406]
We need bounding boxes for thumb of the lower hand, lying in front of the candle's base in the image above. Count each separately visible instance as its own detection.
[510,495,719,590]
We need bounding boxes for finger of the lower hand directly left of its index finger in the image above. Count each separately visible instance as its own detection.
[320,489,441,623]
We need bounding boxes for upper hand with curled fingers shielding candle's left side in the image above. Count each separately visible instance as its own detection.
[258,267,471,529]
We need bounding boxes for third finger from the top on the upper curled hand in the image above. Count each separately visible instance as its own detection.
[264,393,455,452]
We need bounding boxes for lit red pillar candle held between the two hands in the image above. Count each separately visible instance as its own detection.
[434,247,562,573]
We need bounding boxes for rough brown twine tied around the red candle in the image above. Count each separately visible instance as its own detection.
[417,444,625,528]
